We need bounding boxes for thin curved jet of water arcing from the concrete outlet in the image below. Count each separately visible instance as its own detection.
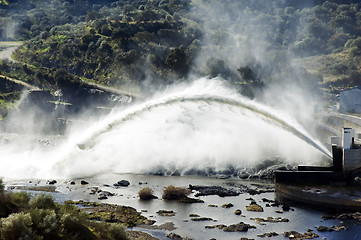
[77,96,332,158]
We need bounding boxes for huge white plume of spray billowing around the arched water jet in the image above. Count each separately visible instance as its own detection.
[0,78,328,178]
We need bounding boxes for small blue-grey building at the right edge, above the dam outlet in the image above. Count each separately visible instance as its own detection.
[340,87,361,113]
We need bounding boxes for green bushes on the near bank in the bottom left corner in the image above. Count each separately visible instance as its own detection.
[0,179,129,240]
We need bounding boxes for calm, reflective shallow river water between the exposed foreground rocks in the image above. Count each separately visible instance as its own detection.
[7,173,360,240]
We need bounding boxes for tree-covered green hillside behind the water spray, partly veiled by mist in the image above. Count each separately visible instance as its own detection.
[0,0,361,119]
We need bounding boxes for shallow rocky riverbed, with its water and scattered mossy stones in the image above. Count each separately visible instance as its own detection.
[6,173,361,240]
